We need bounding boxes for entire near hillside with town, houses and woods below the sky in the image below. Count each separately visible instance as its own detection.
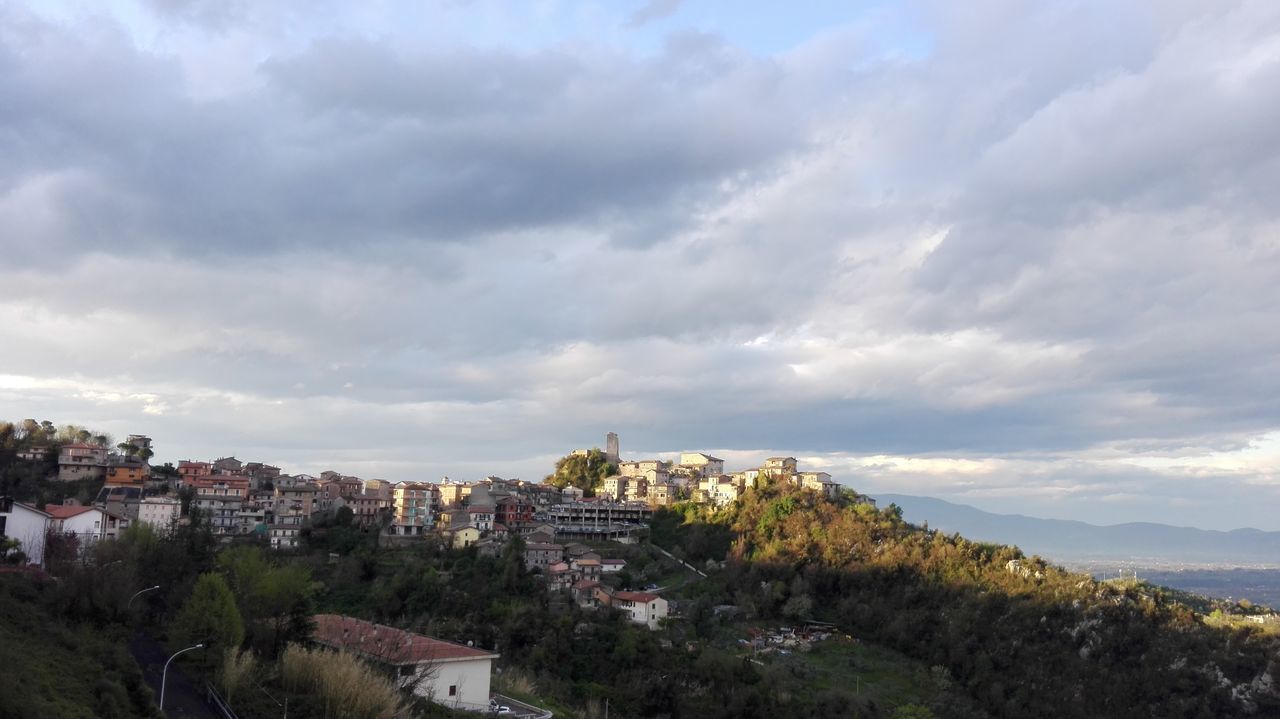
[0,421,1280,719]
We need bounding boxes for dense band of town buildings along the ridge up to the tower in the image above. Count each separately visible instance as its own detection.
[10,432,855,567]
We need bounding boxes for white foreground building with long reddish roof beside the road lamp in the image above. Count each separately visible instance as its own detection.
[312,614,498,711]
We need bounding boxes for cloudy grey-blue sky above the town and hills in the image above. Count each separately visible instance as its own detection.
[0,0,1280,530]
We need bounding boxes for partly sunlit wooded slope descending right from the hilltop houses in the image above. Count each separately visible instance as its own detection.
[654,487,1280,719]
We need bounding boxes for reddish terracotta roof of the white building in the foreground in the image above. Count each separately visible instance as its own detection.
[311,614,498,664]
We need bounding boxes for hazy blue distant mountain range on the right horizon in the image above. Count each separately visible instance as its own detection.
[876,494,1280,567]
